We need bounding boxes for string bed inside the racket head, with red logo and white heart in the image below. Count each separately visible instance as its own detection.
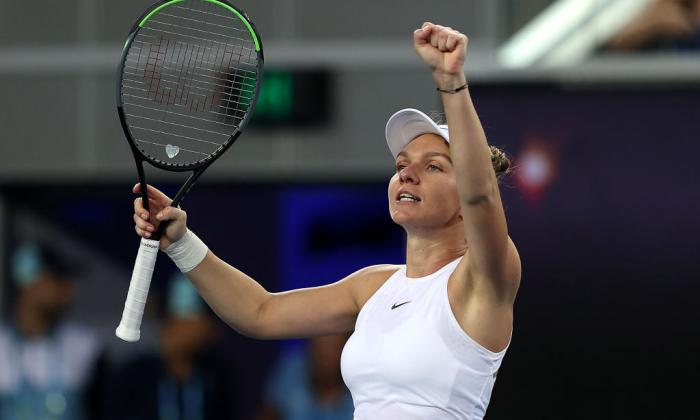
[121,0,261,166]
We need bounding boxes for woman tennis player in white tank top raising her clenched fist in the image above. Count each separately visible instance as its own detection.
[134,22,521,420]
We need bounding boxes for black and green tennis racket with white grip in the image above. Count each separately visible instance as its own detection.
[116,0,263,341]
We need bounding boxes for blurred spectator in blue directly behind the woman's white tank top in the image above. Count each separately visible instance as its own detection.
[257,335,354,420]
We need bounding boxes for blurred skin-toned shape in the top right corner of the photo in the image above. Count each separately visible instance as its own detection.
[606,0,700,51]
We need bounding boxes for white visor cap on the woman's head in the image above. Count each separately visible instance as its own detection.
[385,108,450,158]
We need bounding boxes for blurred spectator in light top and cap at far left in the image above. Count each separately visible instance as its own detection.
[0,244,105,420]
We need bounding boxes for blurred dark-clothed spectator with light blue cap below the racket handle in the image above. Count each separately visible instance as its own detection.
[112,273,235,420]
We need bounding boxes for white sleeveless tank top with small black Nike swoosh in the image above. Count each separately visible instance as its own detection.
[341,258,510,420]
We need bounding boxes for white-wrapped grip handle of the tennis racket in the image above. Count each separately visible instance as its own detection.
[116,238,160,342]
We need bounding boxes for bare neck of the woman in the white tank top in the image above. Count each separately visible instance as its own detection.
[406,224,467,277]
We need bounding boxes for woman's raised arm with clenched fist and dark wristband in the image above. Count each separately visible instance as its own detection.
[414,22,520,303]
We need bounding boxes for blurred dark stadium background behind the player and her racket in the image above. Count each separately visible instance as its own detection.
[0,0,700,420]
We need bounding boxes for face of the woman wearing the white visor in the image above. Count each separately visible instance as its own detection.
[389,134,461,230]
